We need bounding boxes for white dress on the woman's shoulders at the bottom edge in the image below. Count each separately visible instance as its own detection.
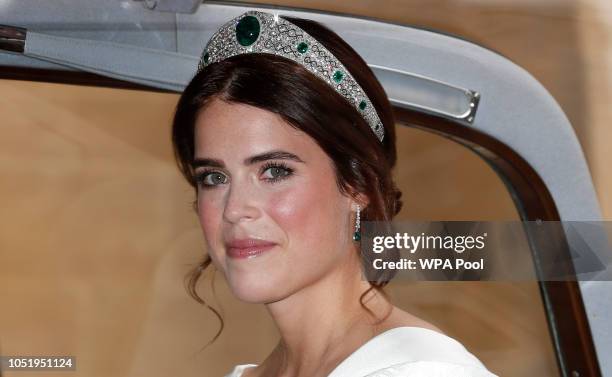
[225,326,498,377]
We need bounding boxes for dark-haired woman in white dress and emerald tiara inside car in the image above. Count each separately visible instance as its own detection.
[173,12,494,377]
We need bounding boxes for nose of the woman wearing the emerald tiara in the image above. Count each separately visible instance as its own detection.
[223,176,260,223]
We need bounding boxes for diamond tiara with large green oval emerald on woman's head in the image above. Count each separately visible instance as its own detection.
[198,11,384,141]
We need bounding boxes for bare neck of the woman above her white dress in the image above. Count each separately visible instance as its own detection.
[266,250,390,376]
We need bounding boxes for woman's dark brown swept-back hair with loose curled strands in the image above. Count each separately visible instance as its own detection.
[172,17,402,342]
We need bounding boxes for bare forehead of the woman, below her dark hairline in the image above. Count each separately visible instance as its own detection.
[194,99,324,159]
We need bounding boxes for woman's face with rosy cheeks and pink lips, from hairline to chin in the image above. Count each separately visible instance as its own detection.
[194,99,356,303]
